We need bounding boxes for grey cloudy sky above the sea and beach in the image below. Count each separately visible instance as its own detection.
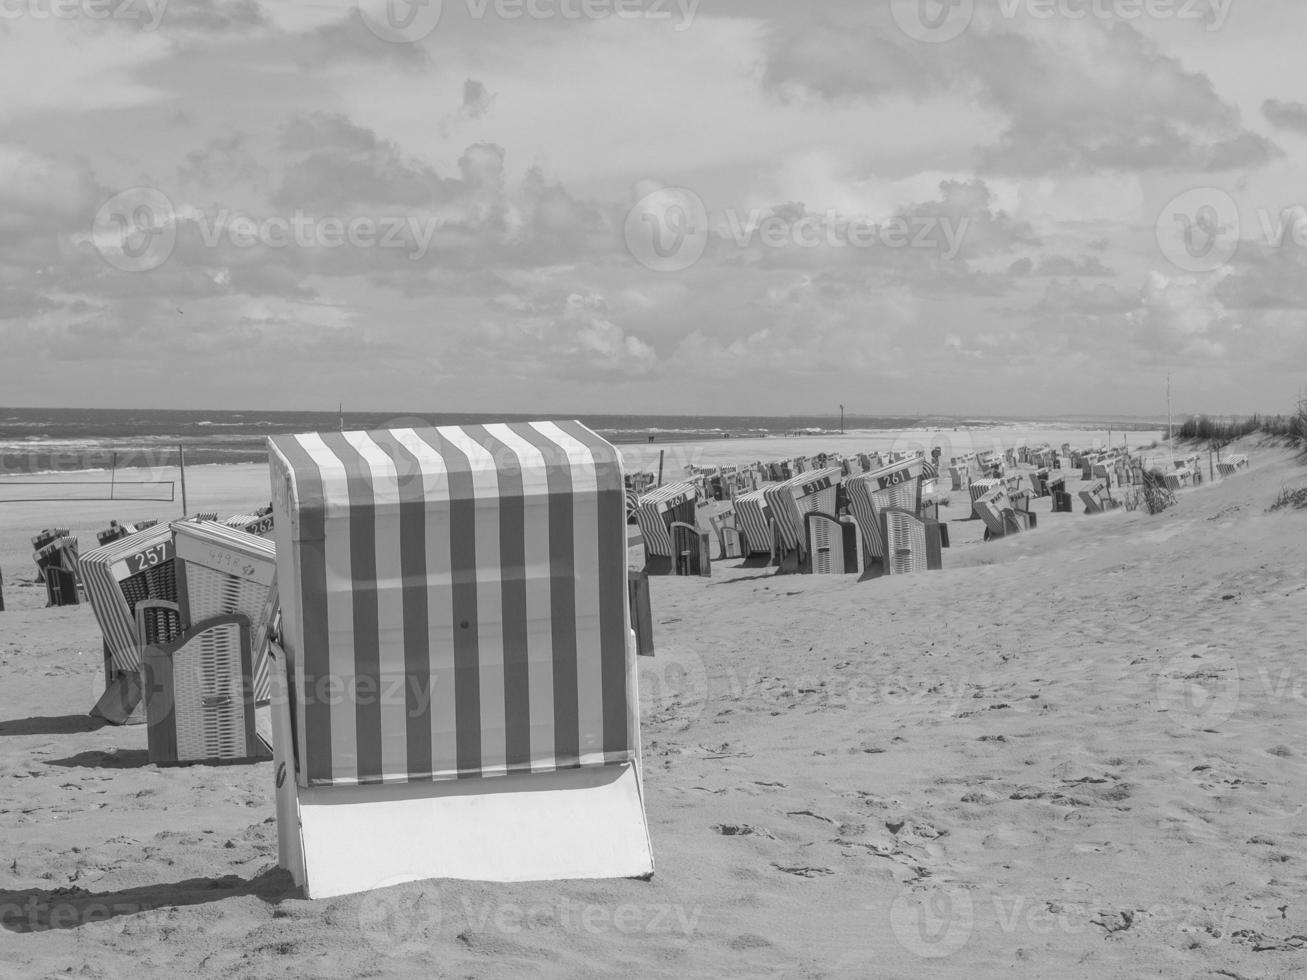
[0,0,1307,417]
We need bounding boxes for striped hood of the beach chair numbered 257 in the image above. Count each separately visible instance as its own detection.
[78,524,176,672]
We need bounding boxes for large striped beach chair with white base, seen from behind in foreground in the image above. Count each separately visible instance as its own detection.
[269,422,654,898]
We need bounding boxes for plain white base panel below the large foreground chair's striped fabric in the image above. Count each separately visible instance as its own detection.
[269,648,654,899]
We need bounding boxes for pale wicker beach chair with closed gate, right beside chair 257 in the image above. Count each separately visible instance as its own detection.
[137,521,277,764]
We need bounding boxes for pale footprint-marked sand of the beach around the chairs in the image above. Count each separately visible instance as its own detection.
[0,440,1307,979]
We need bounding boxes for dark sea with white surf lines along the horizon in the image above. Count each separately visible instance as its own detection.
[0,408,1158,477]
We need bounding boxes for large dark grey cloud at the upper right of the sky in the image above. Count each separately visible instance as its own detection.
[762,5,1281,175]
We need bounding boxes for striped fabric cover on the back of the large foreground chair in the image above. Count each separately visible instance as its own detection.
[269,422,639,785]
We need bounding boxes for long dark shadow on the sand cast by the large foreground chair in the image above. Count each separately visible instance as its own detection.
[0,868,299,933]
